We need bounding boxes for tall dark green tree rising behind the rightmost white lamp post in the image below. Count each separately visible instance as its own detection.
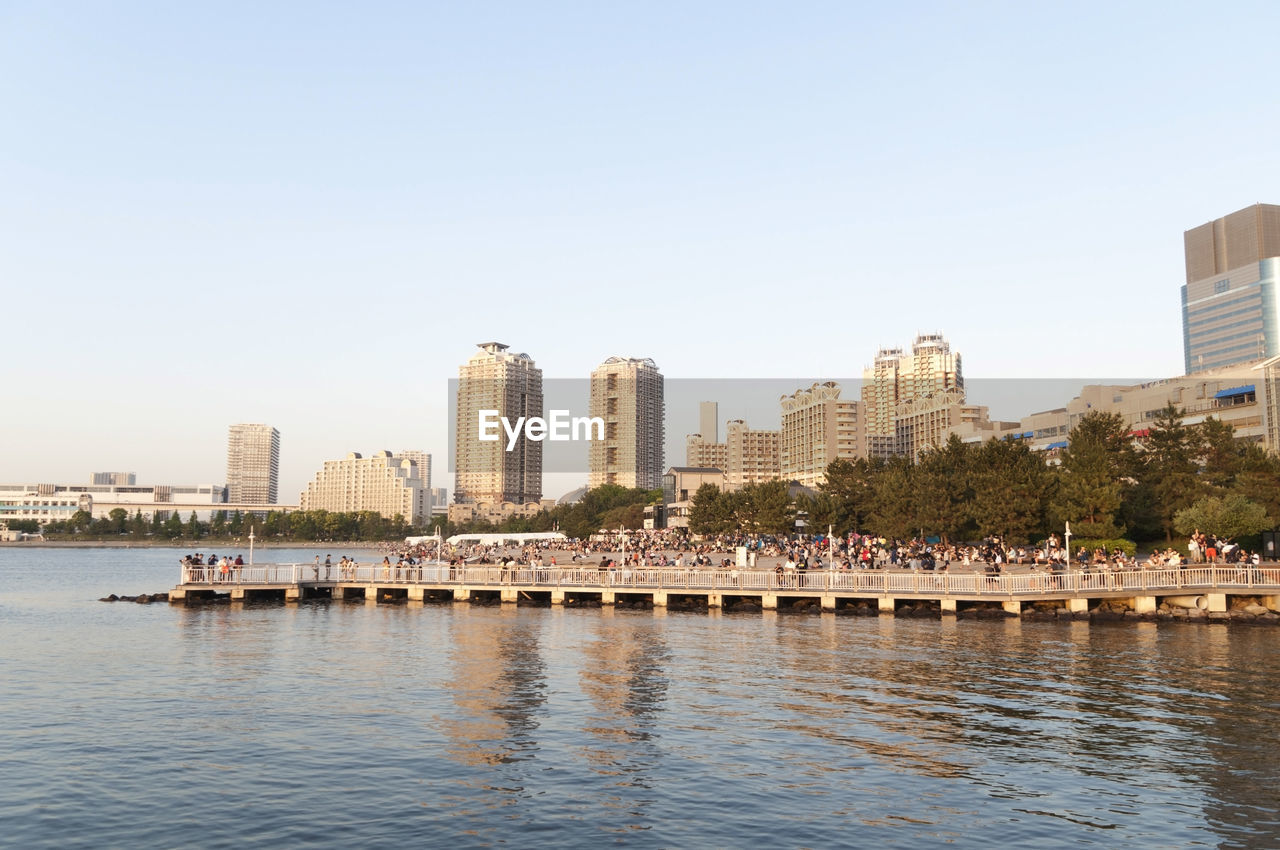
[1052,411,1133,540]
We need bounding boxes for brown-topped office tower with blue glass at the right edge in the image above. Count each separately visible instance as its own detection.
[1183,204,1280,375]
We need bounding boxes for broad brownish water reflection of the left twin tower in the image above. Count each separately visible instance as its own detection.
[435,607,547,766]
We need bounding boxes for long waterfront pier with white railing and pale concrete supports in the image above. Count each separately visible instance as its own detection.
[169,563,1280,617]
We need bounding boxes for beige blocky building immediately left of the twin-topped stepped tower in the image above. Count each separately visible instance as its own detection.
[780,380,861,486]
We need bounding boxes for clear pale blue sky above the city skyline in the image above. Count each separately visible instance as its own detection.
[0,0,1280,502]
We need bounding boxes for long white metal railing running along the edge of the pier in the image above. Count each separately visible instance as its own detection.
[182,563,1280,598]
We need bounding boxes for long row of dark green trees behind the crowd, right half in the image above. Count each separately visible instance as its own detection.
[690,405,1280,544]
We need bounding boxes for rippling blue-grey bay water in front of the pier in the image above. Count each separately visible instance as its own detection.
[0,548,1280,847]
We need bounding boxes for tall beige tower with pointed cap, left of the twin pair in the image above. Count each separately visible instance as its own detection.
[453,342,543,504]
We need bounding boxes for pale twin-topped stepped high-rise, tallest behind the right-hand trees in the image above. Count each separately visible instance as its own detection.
[860,334,964,457]
